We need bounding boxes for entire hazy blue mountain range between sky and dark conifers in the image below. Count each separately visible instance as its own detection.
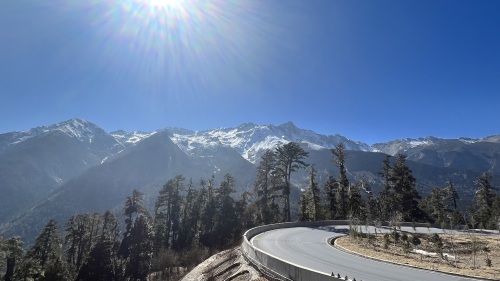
[0,119,500,241]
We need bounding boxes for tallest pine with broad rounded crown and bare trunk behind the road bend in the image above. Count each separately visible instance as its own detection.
[275,142,309,221]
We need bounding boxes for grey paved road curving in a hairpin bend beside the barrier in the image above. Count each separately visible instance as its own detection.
[251,226,478,281]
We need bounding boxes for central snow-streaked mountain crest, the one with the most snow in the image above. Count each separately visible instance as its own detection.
[172,122,371,164]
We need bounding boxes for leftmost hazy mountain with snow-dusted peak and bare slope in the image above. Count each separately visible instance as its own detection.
[0,119,123,223]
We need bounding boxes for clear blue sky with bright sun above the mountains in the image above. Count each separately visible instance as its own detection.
[0,0,500,144]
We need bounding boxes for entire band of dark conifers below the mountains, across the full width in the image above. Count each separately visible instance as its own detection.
[0,142,500,281]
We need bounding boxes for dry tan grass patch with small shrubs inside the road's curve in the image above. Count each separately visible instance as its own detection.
[336,229,500,280]
